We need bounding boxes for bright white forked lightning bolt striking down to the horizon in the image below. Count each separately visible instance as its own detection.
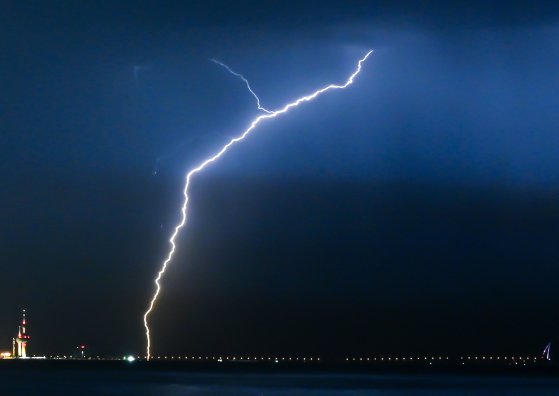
[144,50,373,360]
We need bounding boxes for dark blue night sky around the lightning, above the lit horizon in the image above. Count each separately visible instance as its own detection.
[0,0,559,357]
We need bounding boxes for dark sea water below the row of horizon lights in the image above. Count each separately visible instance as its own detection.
[0,361,559,396]
